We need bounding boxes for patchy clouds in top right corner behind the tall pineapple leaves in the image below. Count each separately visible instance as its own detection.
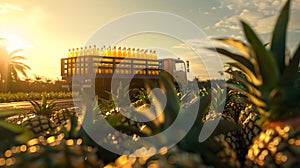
[212,0,300,34]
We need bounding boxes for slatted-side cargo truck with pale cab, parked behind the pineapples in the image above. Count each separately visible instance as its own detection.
[61,46,189,97]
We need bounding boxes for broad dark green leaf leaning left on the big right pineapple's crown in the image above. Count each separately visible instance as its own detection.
[241,21,279,92]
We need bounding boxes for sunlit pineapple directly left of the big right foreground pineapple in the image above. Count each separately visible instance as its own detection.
[223,73,261,167]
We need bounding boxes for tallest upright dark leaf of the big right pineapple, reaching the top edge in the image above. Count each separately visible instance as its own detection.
[271,0,290,72]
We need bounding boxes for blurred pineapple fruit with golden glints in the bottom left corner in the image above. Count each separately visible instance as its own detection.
[0,134,103,168]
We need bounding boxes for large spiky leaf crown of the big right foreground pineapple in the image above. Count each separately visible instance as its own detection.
[210,0,300,119]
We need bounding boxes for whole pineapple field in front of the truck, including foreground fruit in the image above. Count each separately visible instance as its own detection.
[0,0,300,168]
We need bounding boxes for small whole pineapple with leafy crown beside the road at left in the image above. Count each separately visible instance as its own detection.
[21,95,56,136]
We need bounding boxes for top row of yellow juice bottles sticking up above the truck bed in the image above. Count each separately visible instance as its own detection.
[68,45,157,60]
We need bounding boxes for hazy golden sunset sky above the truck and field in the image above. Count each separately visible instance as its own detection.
[0,0,300,79]
